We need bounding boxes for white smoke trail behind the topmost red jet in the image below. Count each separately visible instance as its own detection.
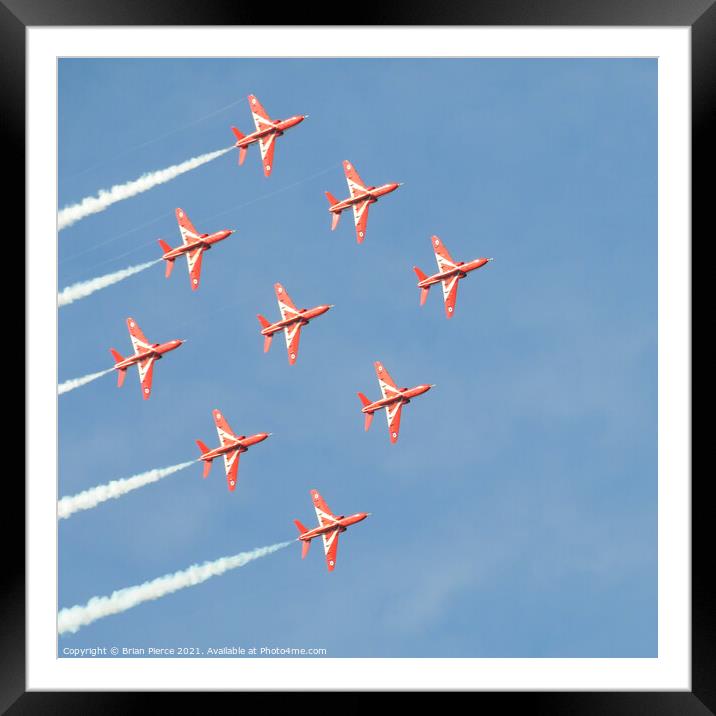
[57,145,234,230]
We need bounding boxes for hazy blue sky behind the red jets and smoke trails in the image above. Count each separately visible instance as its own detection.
[58,60,657,657]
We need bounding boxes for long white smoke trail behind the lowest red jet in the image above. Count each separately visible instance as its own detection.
[57,540,295,634]
